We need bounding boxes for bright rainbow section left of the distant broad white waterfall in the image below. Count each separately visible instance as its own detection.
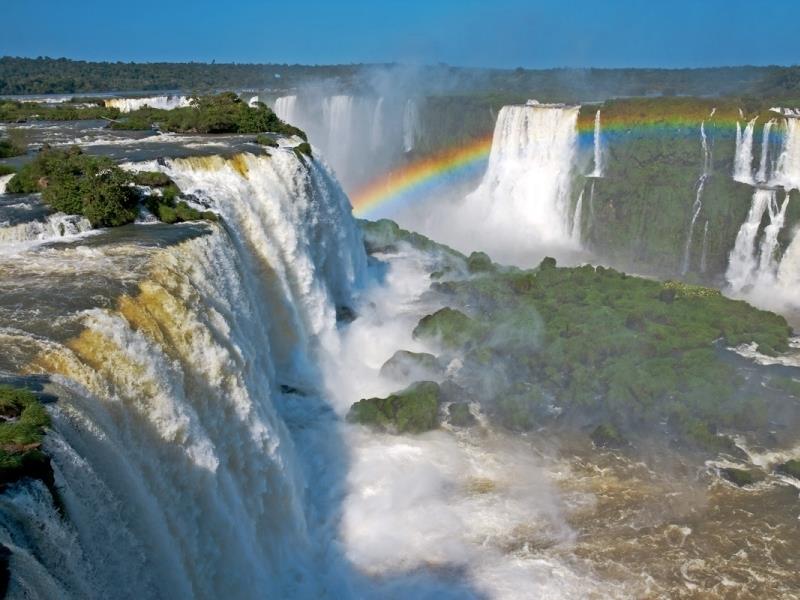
[352,134,492,218]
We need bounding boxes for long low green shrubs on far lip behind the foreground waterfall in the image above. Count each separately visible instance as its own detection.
[111,92,310,138]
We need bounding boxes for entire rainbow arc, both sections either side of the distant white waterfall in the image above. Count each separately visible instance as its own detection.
[351,110,748,219]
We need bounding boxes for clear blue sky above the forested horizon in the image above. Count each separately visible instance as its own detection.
[0,0,800,68]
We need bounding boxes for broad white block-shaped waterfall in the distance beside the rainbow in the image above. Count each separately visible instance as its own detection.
[464,104,578,250]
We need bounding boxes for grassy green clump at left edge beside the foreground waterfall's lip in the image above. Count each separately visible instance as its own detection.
[0,387,53,489]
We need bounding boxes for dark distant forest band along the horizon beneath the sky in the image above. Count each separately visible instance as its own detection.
[0,57,800,102]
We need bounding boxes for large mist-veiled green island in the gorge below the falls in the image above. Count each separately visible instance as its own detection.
[414,259,790,450]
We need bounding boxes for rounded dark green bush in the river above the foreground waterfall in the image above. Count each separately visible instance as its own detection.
[6,146,139,227]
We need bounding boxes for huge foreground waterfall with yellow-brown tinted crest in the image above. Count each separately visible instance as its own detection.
[0,150,366,599]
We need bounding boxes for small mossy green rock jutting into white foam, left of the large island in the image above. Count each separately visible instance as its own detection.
[347,381,440,433]
